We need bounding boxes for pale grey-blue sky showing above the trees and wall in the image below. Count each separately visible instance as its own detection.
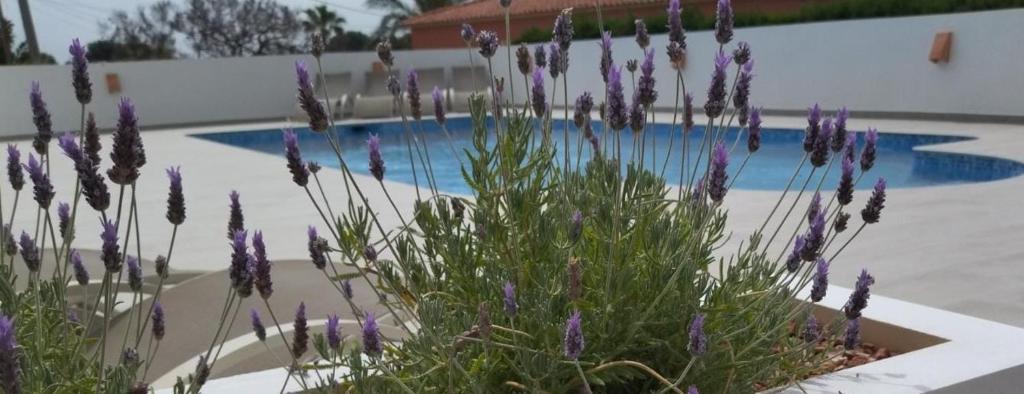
[0,0,383,62]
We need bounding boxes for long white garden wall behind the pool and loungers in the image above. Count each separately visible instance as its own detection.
[0,9,1024,136]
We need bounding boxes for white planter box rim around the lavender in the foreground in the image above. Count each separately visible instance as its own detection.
[158,287,1024,394]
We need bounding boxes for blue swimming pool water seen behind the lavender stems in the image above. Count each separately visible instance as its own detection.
[195,118,1024,193]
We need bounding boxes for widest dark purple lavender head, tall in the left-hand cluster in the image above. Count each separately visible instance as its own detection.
[106,97,145,185]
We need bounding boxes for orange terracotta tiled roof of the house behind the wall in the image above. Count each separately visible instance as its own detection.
[404,0,668,27]
